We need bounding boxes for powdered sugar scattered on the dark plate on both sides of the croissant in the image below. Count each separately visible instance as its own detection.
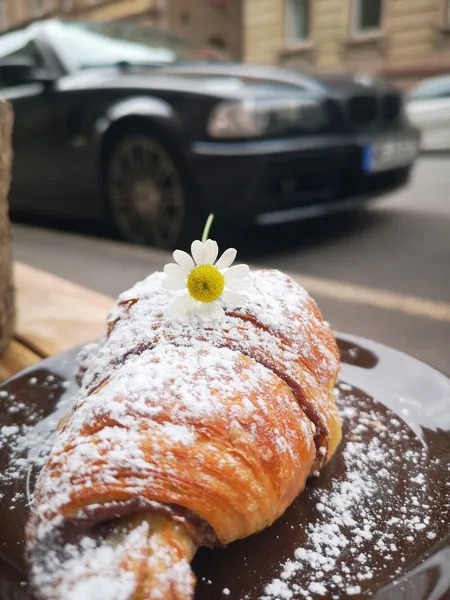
[0,357,448,600]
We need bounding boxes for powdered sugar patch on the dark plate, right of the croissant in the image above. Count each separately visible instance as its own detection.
[261,384,445,600]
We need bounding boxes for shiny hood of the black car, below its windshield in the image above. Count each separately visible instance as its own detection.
[60,63,398,98]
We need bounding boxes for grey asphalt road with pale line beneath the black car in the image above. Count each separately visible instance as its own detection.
[13,156,450,375]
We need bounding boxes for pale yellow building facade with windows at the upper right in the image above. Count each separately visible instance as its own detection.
[244,0,450,87]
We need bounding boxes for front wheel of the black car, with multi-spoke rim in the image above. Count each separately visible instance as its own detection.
[105,130,206,250]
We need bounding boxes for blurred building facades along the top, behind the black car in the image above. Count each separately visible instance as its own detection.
[0,0,450,86]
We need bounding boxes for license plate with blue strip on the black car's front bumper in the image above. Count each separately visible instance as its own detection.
[362,139,417,173]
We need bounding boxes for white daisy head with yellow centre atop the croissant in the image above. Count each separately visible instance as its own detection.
[163,239,250,320]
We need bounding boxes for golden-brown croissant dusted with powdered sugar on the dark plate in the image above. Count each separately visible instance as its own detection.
[26,270,341,600]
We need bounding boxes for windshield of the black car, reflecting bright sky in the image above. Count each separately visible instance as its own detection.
[46,21,225,71]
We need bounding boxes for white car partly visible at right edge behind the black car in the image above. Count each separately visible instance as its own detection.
[406,75,450,150]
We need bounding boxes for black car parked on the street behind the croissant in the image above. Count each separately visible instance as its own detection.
[0,20,418,248]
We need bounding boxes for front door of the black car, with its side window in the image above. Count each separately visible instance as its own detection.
[0,28,63,216]
